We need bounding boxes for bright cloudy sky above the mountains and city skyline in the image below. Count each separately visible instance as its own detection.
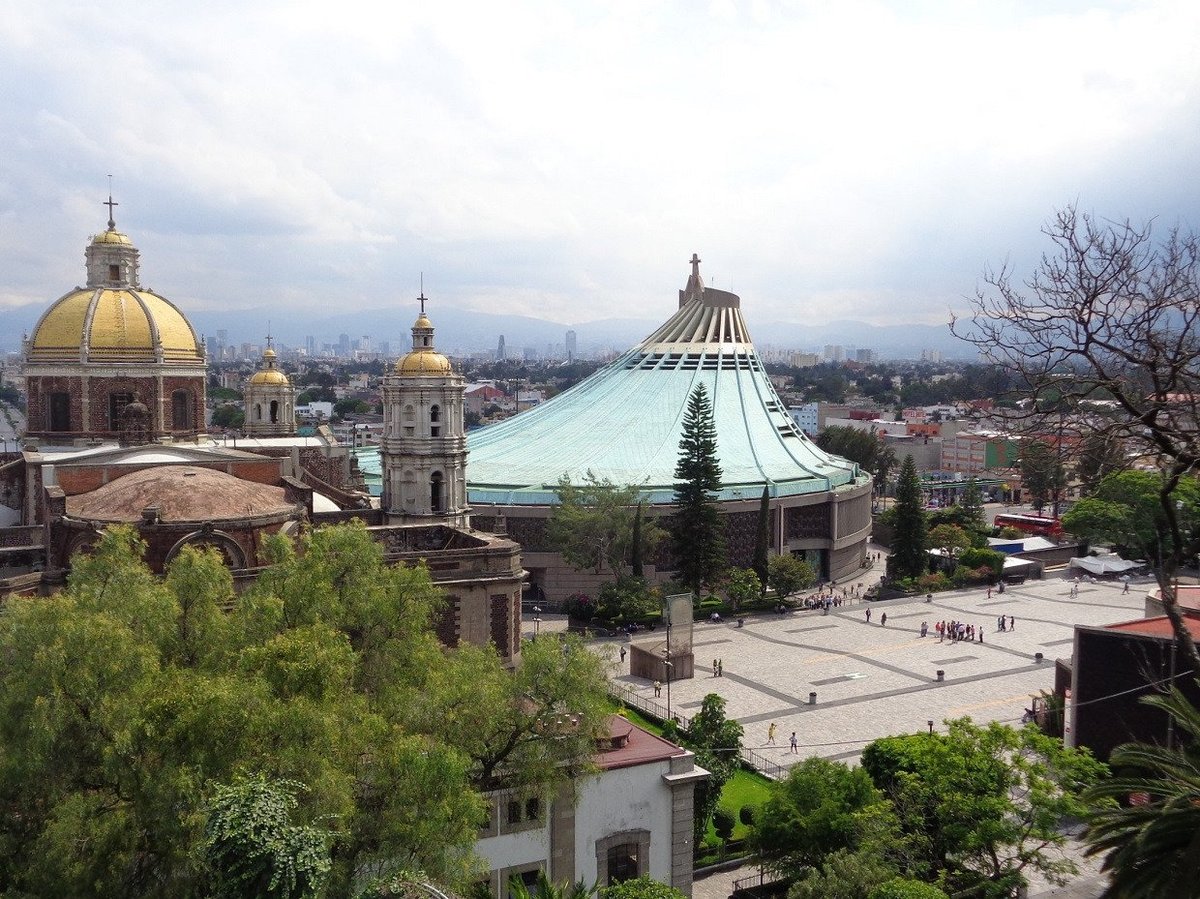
[0,0,1200,324]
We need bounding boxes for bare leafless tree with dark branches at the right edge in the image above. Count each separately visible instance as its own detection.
[950,206,1200,671]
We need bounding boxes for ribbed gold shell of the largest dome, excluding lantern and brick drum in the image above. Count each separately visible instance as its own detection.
[29,284,204,365]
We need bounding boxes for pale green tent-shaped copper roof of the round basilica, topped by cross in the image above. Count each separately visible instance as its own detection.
[467,257,866,505]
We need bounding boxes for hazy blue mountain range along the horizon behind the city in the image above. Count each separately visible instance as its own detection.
[0,300,976,359]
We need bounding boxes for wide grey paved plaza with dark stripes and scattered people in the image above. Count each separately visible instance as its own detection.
[616,547,1148,766]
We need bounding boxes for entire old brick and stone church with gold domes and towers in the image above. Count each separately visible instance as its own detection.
[0,206,524,660]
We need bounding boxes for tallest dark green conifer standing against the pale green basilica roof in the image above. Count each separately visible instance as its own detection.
[671,384,726,597]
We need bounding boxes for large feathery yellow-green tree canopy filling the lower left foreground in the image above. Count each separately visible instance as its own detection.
[0,525,604,899]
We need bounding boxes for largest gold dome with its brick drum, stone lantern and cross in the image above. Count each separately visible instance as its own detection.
[24,198,205,442]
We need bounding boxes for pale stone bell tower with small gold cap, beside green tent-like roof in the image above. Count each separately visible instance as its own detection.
[379,294,467,527]
